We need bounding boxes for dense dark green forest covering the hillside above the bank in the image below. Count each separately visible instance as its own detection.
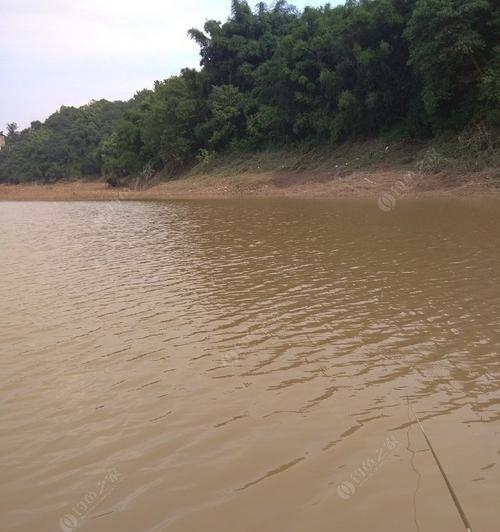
[0,0,500,181]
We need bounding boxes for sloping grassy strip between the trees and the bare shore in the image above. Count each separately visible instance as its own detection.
[183,126,500,181]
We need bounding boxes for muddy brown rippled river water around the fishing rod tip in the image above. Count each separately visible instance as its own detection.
[0,200,500,532]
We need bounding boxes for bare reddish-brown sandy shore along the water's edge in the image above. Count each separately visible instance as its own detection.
[0,169,500,201]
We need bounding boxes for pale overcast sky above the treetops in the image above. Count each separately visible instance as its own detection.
[0,0,340,129]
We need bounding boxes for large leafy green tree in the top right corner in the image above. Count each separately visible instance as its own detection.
[405,0,500,130]
